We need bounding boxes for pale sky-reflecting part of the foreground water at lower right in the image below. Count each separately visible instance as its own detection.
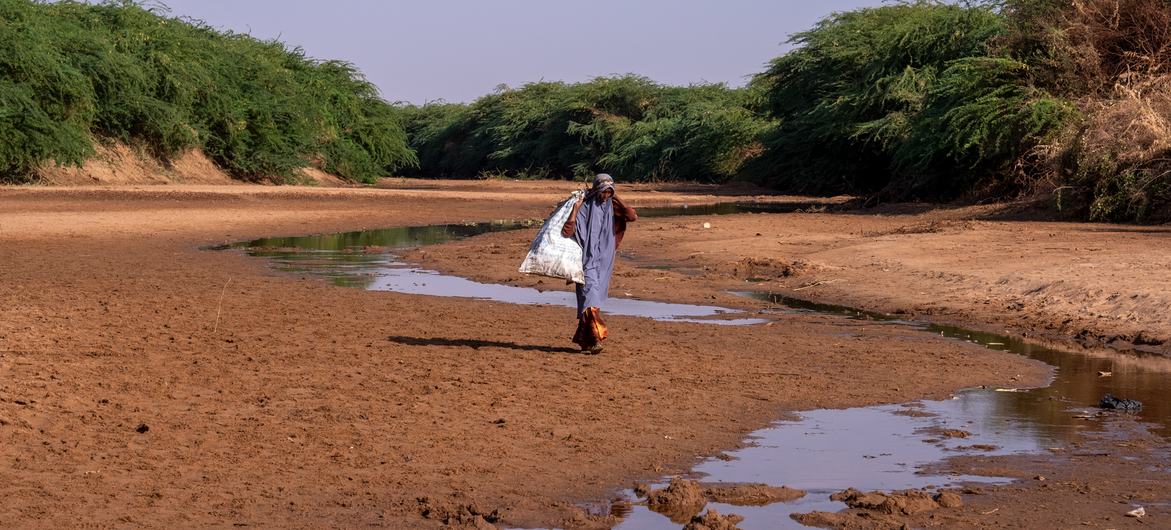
[616,394,1047,530]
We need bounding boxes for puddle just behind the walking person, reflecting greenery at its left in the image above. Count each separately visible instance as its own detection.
[226,221,768,325]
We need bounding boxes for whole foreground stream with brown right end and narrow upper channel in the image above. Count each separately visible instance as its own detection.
[599,292,1171,530]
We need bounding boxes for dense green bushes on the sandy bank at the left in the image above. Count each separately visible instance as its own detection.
[0,0,415,181]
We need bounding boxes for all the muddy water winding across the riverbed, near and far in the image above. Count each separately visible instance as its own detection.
[217,216,1171,529]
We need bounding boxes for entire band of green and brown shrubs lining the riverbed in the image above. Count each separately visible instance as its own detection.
[9,0,1171,220]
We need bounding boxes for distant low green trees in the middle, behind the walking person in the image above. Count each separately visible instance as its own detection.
[403,75,766,181]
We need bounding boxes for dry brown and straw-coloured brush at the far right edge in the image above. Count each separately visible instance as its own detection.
[1038,0,1171,220]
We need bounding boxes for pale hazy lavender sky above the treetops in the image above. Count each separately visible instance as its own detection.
[153,0,881,103]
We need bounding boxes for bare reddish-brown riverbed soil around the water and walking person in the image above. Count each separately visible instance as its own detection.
[0,180,1171,528]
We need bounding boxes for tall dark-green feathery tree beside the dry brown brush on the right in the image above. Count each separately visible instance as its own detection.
[749,1,1070,198]
